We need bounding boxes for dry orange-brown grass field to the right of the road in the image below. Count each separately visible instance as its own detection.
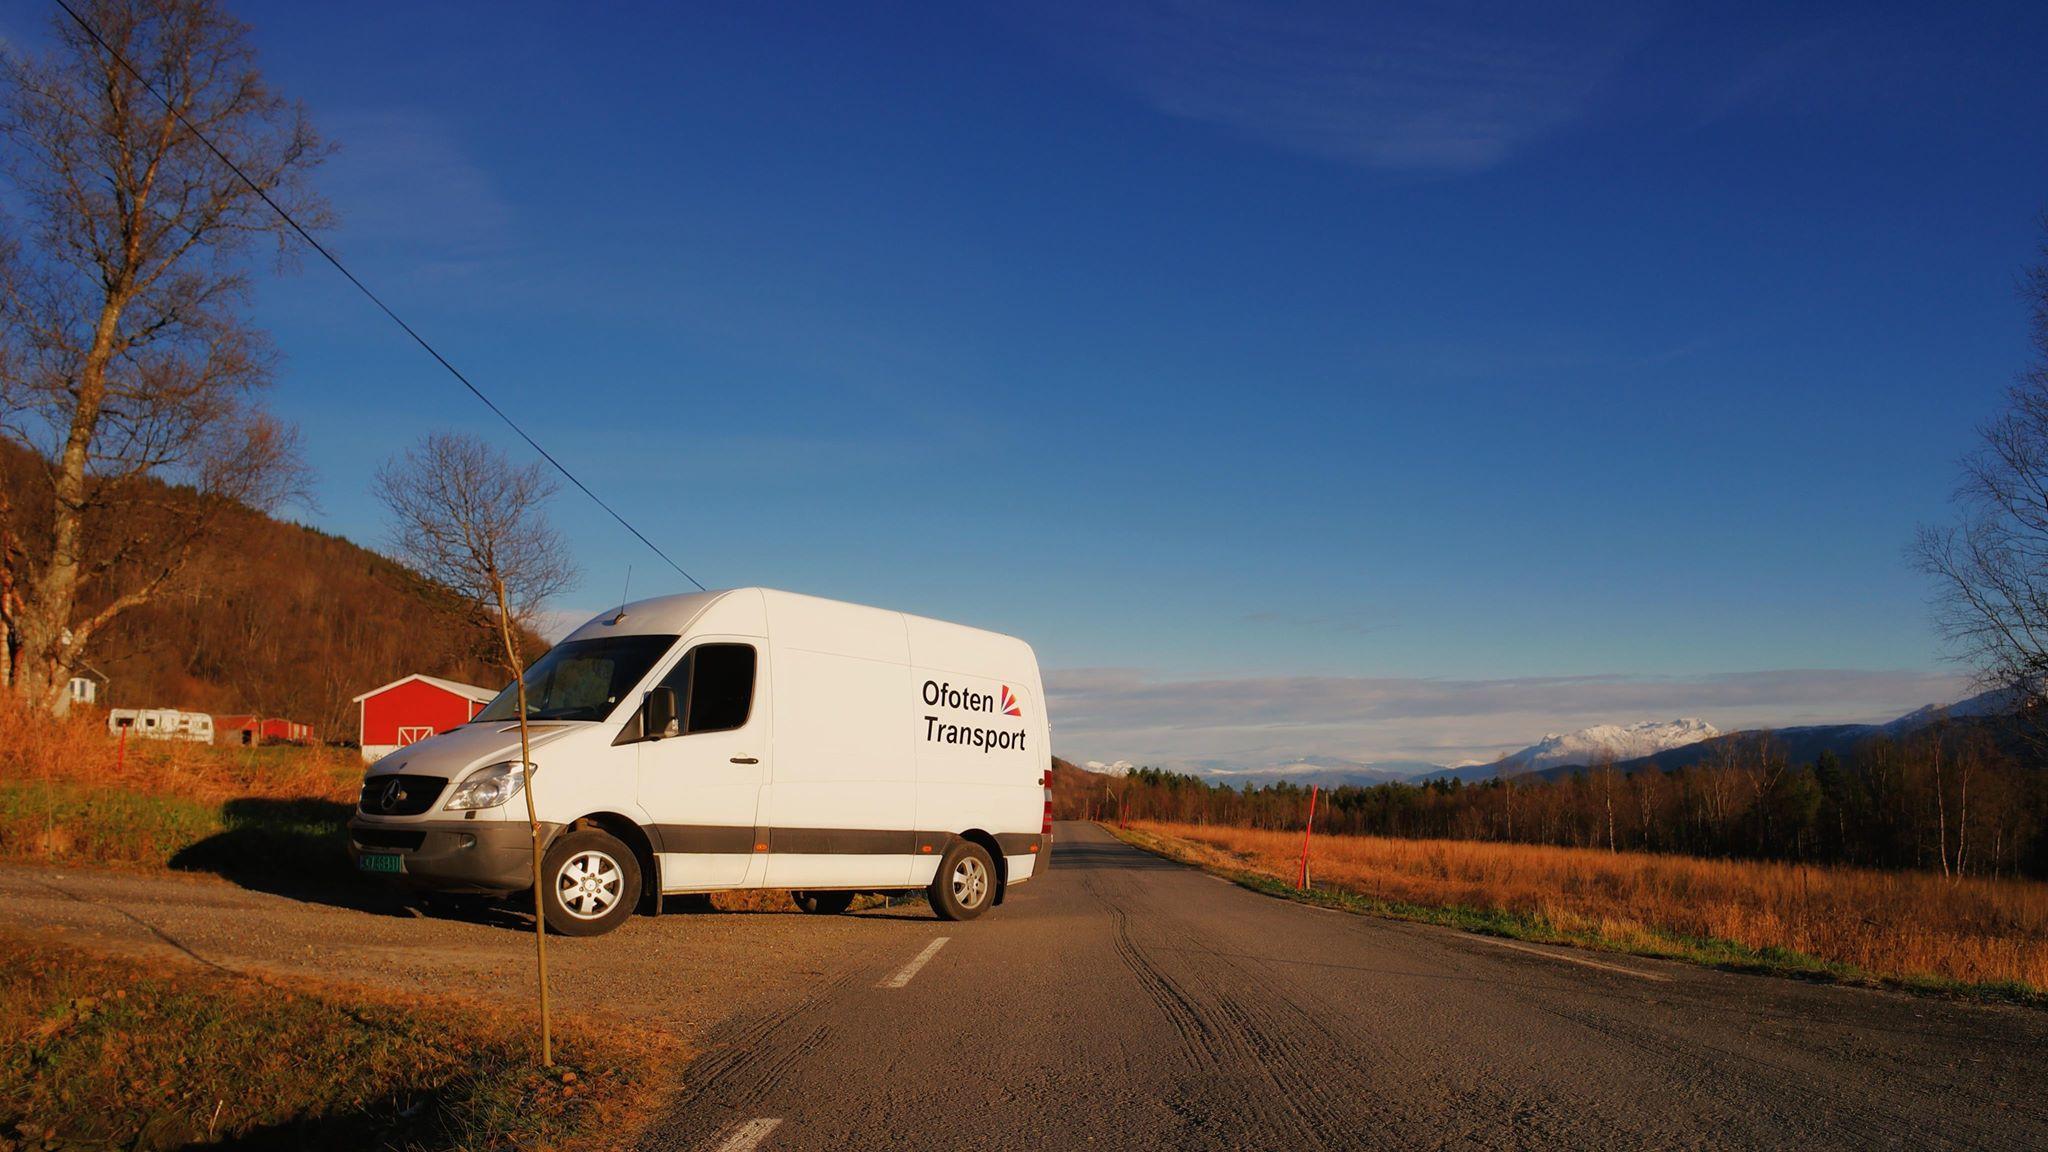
[1120,822,2048,1004]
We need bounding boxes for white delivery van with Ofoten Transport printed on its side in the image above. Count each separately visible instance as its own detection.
[348,588,1053,935]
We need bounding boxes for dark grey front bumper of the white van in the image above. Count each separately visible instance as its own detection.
[348,814,555,896]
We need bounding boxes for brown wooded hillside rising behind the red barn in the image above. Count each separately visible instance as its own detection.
[0,443,547,740]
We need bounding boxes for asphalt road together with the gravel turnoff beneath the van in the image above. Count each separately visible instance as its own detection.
[0,824,2048,1152]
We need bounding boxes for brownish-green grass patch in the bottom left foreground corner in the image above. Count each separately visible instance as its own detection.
[0,937,682,1150]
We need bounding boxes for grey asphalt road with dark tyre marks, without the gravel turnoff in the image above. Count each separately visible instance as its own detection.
[649,824,2048,1152]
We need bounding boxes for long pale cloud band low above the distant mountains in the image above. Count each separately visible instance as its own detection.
[1047,668,1970,769]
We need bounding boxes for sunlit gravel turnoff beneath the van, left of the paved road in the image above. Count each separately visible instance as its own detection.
[0,865,932,1041]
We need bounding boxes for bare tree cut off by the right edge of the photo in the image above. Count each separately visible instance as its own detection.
[1911,215,2048,733]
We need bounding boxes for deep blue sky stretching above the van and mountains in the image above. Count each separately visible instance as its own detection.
[0,0,2048,765]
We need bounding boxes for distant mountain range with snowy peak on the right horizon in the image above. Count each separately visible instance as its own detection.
[1146,691,2015,787]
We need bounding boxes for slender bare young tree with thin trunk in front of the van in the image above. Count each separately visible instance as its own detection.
[375,433,575,1064]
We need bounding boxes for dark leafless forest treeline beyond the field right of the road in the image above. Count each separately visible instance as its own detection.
[1055,722,2048,877]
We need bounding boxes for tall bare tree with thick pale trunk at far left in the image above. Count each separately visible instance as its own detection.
[0,0,330,711]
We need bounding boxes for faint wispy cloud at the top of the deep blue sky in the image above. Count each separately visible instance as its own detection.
[1026,0,1647,172]
